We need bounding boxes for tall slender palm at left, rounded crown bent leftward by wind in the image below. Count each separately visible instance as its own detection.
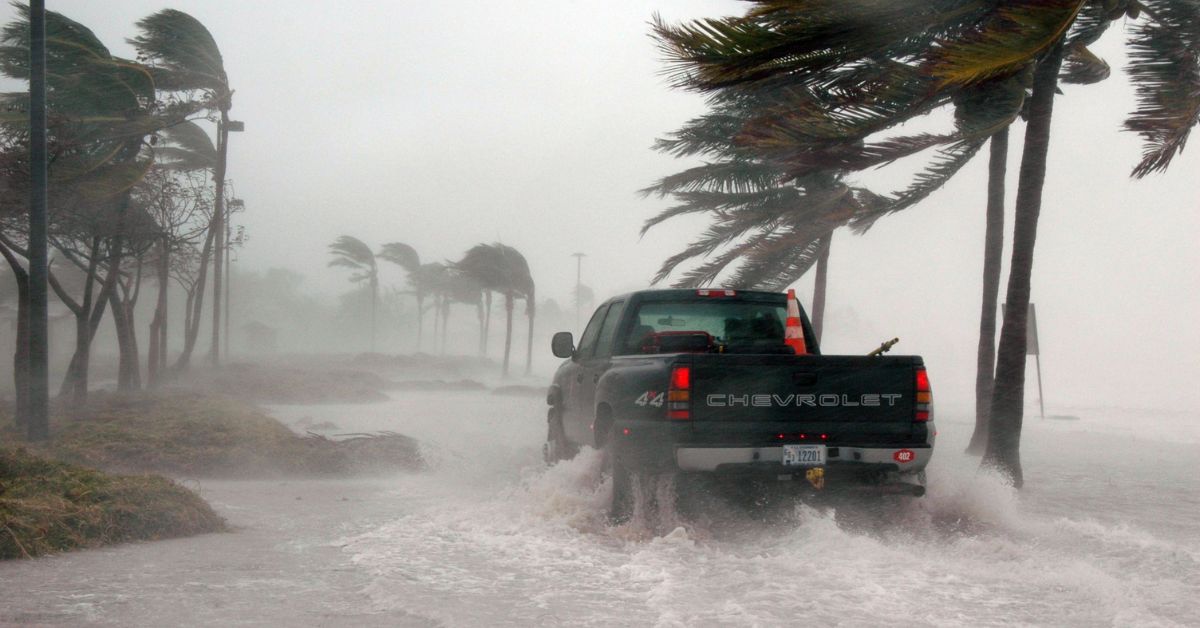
[128,8,233,365]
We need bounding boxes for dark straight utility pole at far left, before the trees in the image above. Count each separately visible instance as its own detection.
[28,0,50,441]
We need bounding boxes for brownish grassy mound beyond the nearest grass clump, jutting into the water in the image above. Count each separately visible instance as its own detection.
[12,390,421,478]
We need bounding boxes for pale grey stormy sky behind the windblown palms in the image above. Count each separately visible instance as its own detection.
[9,0,1200,412]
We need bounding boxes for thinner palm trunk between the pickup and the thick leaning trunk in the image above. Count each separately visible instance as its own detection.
[967,126,1008,455]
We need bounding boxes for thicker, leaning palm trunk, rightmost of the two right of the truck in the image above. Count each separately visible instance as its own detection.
[983,42,1063,488]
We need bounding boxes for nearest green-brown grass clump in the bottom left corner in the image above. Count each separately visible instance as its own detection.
[0,448,226,558]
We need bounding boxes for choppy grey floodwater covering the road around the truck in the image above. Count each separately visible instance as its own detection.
[0,391,1200,627]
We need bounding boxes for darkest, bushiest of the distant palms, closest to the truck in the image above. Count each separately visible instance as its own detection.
[454,243,536,377]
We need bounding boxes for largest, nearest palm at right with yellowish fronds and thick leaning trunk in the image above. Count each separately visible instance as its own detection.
[656,0,1200,484]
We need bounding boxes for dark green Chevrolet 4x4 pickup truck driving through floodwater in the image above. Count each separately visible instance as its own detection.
[545,289,936,519]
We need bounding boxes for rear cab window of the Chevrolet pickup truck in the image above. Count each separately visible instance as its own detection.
[622,299,791,354]
